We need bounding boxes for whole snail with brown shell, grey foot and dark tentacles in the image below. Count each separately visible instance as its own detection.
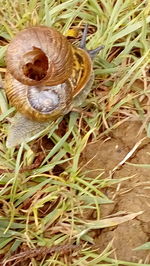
[5,26,103,147]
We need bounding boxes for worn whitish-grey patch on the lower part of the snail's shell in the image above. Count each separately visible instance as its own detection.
[28,86,59,113]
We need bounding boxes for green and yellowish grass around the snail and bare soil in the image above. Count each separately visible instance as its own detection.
[0,0,150,266]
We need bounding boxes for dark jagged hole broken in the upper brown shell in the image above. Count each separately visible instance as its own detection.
[22,47,48,81]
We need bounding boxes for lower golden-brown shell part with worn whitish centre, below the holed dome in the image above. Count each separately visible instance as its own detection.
[5,72,72,122]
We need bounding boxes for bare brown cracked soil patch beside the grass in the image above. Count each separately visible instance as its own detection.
[82,121,150,263]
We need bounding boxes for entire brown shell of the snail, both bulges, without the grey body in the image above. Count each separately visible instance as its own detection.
[5,26,92,122]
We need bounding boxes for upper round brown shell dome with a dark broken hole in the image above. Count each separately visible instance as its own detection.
[6,26,73,86]
